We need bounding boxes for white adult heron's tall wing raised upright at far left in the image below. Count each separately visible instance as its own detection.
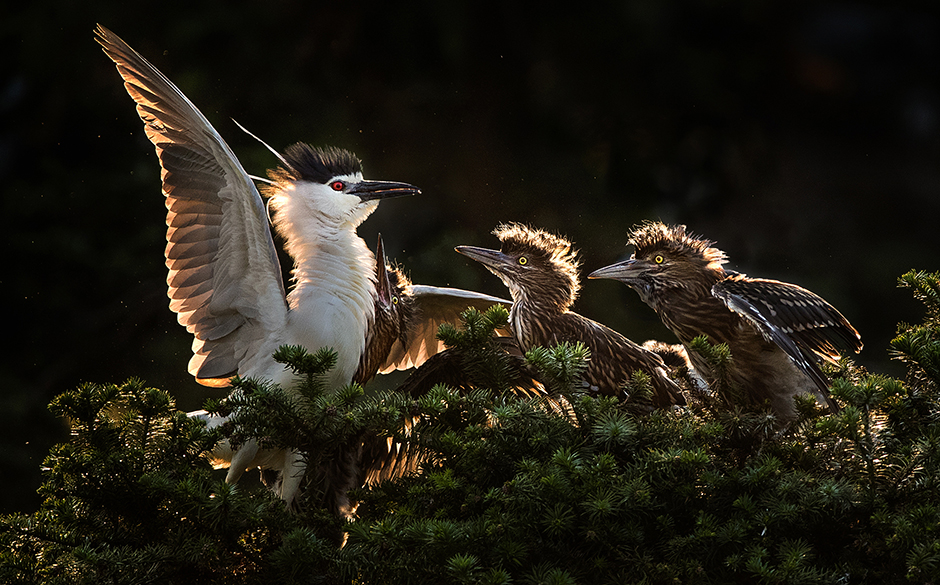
[96,25,288,385]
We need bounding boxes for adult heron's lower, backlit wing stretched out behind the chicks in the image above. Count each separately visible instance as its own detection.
[379,285,512,374]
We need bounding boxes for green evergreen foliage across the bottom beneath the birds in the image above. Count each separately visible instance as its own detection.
[0,272,940,584]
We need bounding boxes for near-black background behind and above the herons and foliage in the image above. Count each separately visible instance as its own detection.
[0,0,940,511]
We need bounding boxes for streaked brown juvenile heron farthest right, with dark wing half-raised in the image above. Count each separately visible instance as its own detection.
[588,222,862,422]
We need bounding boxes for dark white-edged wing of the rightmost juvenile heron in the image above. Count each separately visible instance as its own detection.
[712,274,862,391]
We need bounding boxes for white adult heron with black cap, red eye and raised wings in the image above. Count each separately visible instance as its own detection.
[96,26,516,513]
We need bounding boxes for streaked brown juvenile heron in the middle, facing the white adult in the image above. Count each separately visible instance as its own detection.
[457,223,685,407]
